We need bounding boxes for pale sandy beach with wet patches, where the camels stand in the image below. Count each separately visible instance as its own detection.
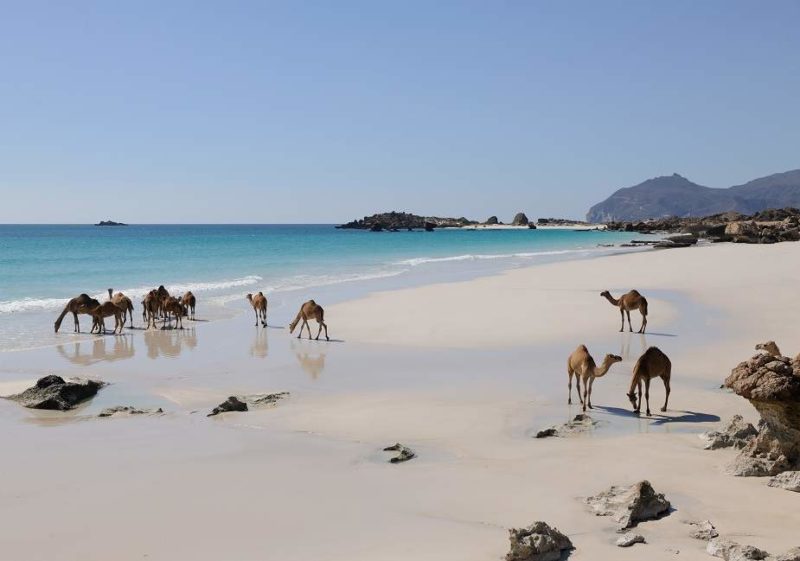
[0,243,800,561]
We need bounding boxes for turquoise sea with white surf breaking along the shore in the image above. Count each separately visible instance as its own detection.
[0,225,644,351]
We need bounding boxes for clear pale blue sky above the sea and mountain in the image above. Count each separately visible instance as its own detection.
[0,0,800,223]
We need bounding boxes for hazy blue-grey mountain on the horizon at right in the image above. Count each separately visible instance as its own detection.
[586,169,800,223]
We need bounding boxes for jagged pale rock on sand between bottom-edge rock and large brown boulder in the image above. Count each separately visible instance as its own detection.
[585,481,671,531]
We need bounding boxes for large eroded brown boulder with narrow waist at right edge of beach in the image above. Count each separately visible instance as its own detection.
[725,354,800,477]
